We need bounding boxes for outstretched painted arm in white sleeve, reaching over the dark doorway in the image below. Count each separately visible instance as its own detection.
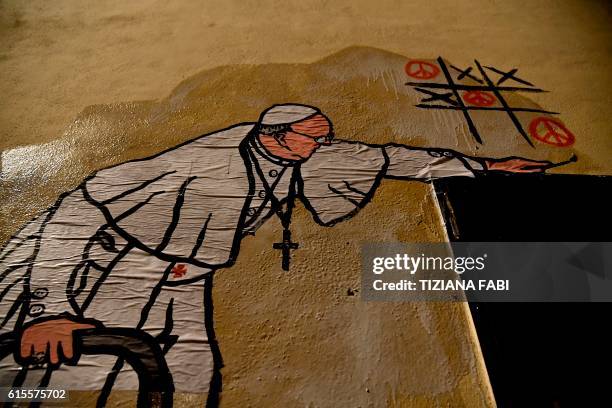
[299,140,554,226]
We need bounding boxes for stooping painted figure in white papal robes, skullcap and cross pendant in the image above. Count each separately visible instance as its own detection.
[0,104,550,402]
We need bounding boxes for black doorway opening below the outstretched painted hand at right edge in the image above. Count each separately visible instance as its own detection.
[434,173,612,408]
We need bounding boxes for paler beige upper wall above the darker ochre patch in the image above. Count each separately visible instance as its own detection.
[0,0,612,166]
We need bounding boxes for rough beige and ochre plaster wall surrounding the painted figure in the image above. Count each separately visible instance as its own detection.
[0,1,612,406]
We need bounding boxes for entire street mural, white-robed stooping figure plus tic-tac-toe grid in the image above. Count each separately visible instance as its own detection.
[0,49,576,406]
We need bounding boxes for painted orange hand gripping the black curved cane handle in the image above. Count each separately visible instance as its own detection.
[20,316,96,365]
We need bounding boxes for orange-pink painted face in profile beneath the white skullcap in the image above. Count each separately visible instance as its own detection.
[279,114,333,160]
